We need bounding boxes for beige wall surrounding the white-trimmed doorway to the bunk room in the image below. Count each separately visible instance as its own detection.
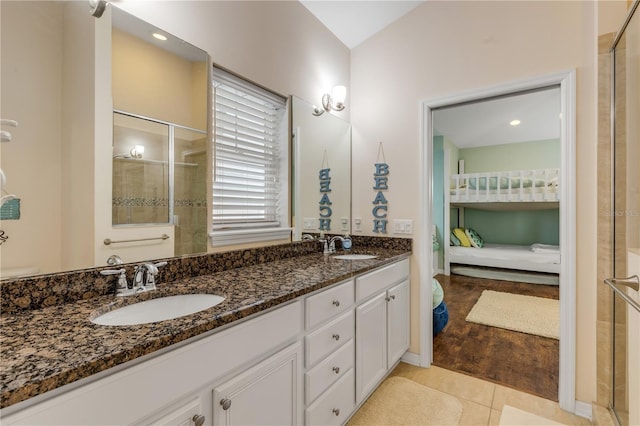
[351,1,597,402]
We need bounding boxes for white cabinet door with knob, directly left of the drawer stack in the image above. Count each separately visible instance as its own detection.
[213,343,302,426]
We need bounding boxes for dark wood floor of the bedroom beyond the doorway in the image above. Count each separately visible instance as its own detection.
[433,275,559,401]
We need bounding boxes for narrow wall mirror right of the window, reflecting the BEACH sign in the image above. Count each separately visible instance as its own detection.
[291,96,351,240]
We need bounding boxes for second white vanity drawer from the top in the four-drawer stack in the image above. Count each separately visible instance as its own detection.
[304,310,355,368]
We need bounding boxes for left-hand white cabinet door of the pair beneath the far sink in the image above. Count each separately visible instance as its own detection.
[356,292,387,405]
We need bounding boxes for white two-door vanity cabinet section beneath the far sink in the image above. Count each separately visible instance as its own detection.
[356,260,409,404]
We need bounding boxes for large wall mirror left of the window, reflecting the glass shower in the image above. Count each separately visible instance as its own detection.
[0,1,209,278]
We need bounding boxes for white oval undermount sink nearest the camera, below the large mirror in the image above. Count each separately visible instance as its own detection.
[91,294,225,325]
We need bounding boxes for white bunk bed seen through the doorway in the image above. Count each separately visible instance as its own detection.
[444,157,560,275]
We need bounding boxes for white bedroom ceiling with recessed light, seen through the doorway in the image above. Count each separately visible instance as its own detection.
[433,87,560,148]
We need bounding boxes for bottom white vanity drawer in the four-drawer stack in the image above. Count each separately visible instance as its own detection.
[305,368,355,426]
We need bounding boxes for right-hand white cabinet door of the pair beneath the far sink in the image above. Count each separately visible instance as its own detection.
[387,280,409,368]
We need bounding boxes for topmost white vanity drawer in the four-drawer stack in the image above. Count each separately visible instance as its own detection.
[305,280,355,330]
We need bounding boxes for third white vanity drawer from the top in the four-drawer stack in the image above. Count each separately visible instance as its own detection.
[305,339,355,404]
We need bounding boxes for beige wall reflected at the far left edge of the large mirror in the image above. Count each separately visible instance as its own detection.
[0,2,64,273]
